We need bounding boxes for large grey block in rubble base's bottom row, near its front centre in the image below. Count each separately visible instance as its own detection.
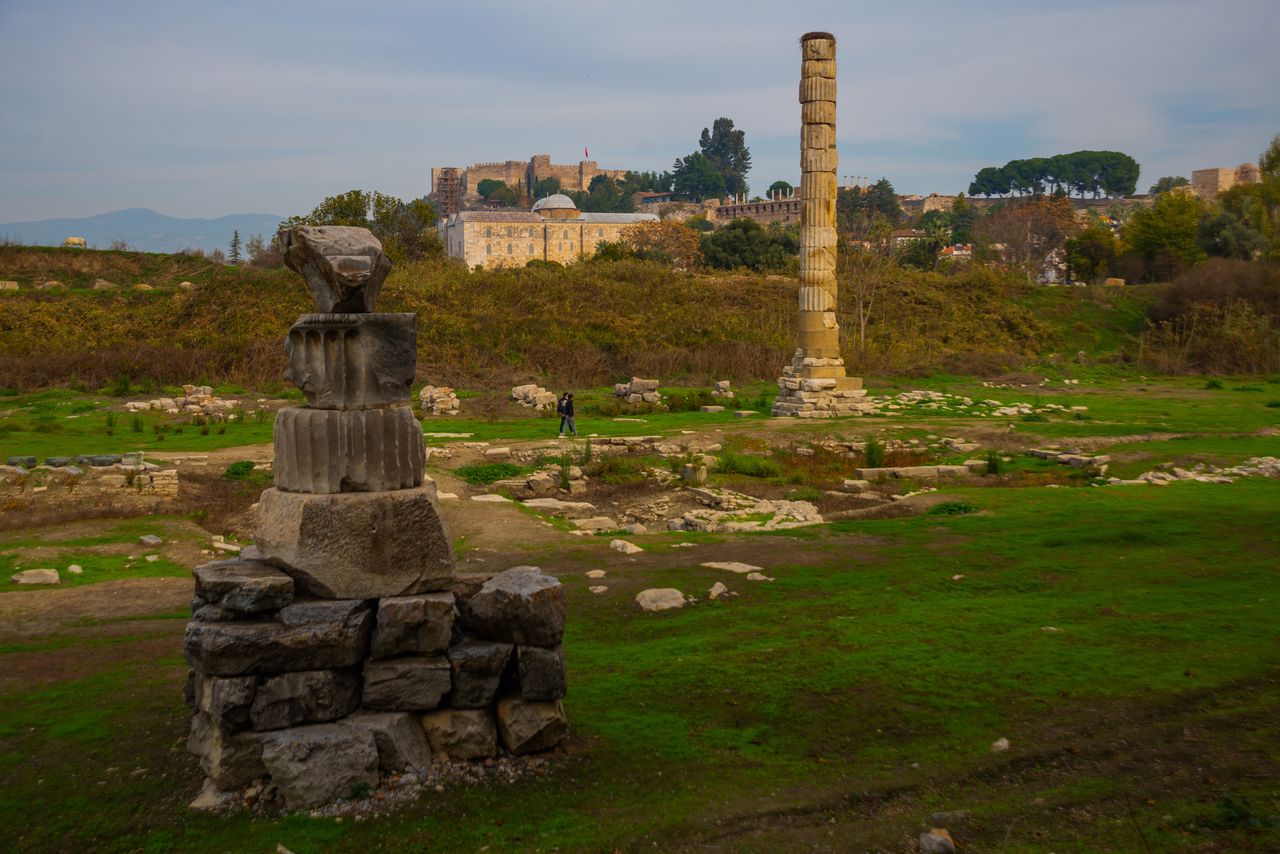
[262,723,378,809]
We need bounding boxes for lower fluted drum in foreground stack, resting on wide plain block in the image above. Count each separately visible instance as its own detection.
[275,406,426,494]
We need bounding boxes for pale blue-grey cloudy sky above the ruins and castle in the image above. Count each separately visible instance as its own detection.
[0,0,1280,222]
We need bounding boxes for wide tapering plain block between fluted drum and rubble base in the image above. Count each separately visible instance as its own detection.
[256,483,453,599]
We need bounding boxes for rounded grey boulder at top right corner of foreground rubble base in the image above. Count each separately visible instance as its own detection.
[460,567,564,647]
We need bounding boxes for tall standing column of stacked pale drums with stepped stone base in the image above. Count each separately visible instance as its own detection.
[773,32,867,417]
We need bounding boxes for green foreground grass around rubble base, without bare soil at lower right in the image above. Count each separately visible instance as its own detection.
[0,481,1280,851]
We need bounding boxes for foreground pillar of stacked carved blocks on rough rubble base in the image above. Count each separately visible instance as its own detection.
[183,227,567,810]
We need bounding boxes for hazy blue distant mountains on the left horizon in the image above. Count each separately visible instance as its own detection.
[0,207,284,252]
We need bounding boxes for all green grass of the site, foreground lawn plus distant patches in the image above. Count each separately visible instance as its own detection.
[0,378,1280,854]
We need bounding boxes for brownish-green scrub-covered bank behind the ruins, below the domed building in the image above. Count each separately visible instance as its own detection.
[0,246,1146,389]
